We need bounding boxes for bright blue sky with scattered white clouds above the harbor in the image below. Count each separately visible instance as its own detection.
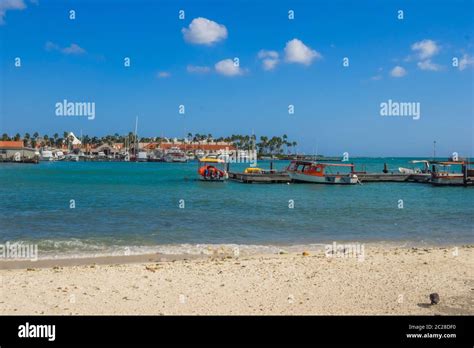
[0,0,474,156]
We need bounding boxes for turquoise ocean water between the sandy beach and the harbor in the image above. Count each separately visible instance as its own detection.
[0,158,474,258]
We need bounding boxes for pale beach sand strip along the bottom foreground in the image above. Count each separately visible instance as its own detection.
[0,245,474,315]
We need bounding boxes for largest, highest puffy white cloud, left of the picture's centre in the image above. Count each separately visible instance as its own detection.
[181,17,227,45]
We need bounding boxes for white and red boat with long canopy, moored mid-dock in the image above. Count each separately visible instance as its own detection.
[286,160,359,185]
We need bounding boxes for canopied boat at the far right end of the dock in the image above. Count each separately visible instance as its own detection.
[431,161,474,186]
